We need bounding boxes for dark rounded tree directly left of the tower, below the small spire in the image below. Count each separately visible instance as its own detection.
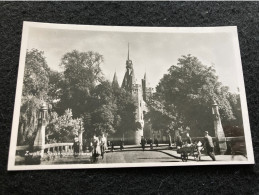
[84,81,136,137]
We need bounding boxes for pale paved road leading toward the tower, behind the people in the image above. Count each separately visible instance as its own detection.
[16,145,247,165]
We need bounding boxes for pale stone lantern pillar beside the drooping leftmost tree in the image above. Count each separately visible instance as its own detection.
[33,103,48,157]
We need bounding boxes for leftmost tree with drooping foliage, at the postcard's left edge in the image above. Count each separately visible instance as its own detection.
[17,49,50,145]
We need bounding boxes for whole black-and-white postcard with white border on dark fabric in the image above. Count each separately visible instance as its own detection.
[8,22,254,170]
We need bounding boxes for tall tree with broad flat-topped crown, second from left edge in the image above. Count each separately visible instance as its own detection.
[58,50,103,117]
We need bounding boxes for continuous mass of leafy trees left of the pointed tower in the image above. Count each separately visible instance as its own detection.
[18,49,135,144]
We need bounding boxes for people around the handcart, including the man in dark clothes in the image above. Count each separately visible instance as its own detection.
[176,131,216,161]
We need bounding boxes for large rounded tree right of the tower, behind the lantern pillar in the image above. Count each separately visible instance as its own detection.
[156,55,240,136]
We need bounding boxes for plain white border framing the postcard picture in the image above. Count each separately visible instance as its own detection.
[7,21,255,170]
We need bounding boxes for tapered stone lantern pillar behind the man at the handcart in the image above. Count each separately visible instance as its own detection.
[212,101,227,154]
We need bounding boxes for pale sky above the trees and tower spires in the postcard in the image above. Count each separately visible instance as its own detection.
[27,27,242,92]
